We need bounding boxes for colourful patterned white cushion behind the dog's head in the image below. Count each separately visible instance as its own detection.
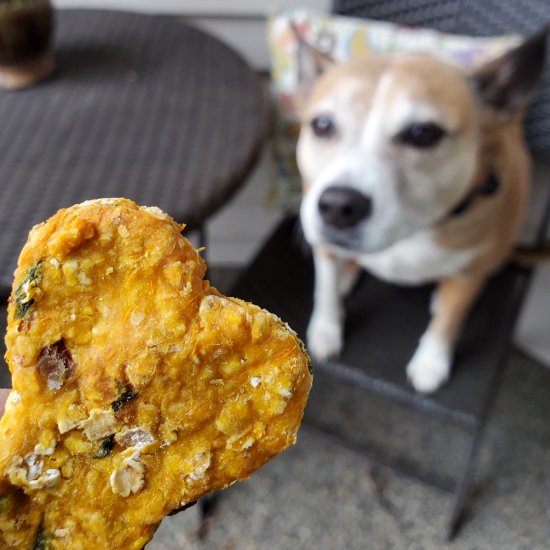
[268,8,521,208]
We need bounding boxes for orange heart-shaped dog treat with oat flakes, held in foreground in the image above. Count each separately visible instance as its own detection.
[0,199,312,550]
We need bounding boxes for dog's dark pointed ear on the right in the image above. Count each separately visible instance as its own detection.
[473,24,550,116]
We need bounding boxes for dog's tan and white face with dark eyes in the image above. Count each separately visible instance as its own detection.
[298,55,481,253]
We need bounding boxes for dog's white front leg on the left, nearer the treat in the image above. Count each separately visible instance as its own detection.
[307,247,344,361]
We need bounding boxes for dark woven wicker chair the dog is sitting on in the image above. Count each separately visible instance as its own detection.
[233,0,550,538]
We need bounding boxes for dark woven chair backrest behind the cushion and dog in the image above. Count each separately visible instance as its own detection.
[333,0,550,158]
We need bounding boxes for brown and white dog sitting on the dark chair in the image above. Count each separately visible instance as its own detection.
[297,29,547,393]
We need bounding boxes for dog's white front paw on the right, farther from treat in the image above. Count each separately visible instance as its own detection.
[407,334,452,394]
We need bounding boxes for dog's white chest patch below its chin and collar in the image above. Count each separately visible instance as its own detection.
[357,231,476,285]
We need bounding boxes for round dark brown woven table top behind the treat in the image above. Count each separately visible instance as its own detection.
[0,10,267,293]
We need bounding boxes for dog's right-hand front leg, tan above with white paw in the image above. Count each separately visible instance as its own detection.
[407,276,485,393]
